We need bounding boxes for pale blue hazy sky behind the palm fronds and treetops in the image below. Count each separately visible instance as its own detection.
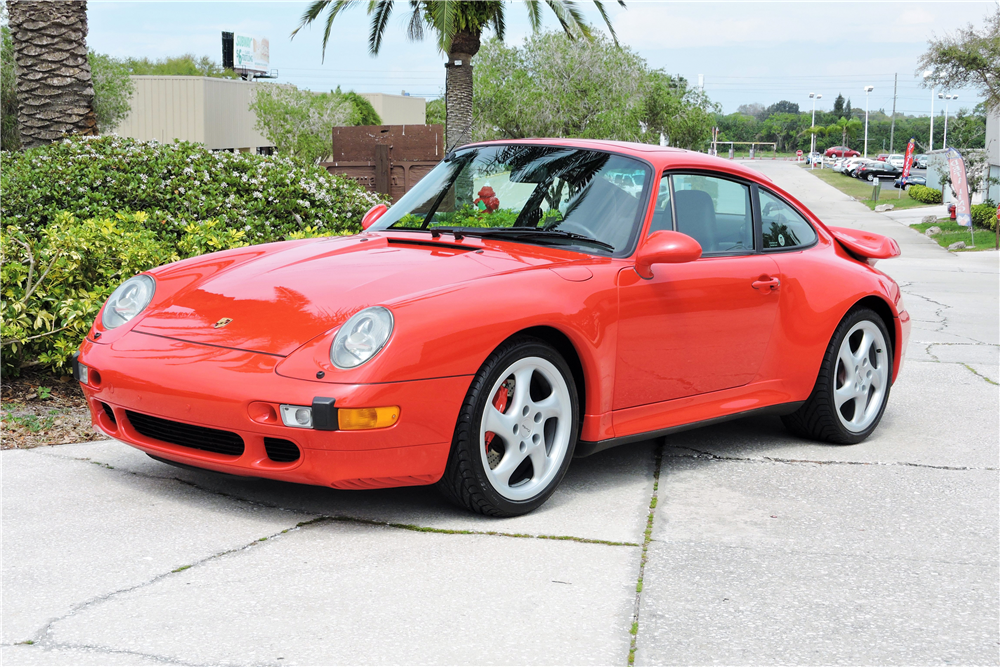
[88,0,997,115]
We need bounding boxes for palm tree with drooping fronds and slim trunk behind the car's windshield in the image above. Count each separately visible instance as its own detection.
[292,0,625,150]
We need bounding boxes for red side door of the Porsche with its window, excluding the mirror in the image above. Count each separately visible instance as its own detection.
[614,174,780,410]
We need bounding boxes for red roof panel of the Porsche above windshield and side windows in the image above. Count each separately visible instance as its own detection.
[460,139,772,183]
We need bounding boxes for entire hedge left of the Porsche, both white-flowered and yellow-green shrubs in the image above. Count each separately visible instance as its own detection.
[0,136,384,374]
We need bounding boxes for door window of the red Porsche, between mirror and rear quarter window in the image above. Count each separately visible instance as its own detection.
[671,174,753,254]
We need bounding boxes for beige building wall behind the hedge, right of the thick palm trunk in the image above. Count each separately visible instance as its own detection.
[115,76,271,151]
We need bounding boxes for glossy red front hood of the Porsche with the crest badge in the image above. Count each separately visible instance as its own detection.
[134,233,581,356]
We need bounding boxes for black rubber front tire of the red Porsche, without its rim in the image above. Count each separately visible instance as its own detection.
[437,336,580,517]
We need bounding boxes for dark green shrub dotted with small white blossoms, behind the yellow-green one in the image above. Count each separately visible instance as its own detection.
[0,135,384,243]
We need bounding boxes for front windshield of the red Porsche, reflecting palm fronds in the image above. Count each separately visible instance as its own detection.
[371,145,650,254]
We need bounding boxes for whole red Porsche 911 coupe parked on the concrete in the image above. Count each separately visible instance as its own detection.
[74,140,910,516]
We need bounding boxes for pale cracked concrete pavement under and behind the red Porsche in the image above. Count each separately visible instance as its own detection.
[7,162,1000,665]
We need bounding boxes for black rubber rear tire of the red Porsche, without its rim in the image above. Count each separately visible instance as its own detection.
[781,307,893,445]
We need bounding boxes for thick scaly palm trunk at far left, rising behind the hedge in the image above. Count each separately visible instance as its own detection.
[7,0,97,148]
